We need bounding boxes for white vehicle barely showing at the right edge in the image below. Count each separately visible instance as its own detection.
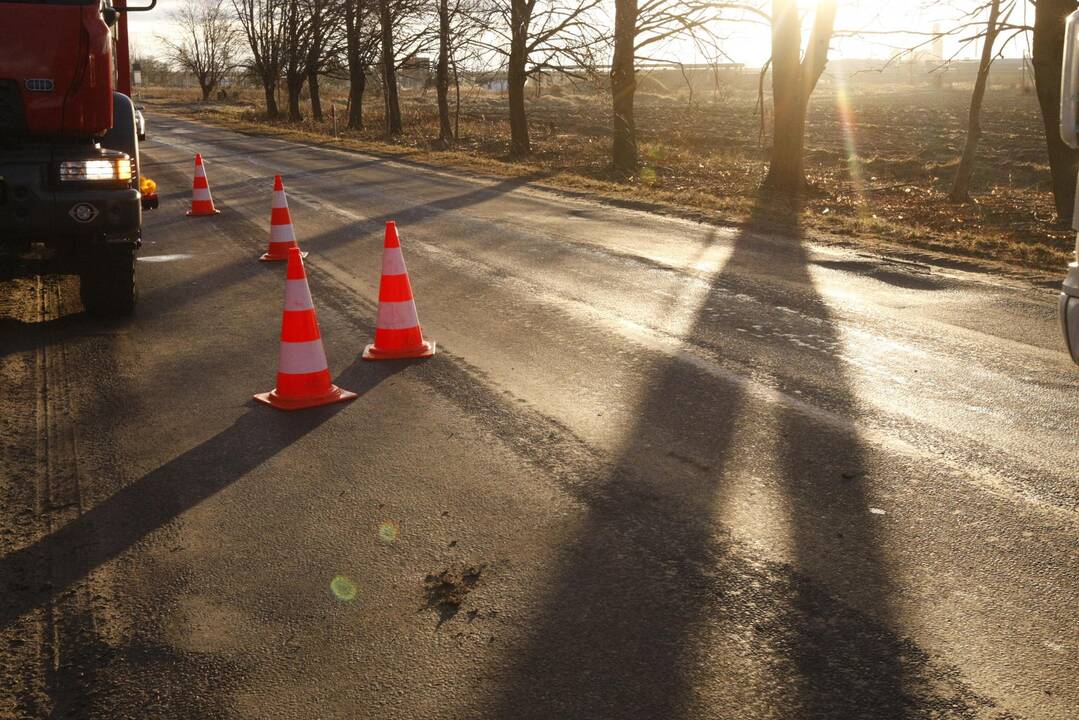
[1061,10,1079,363]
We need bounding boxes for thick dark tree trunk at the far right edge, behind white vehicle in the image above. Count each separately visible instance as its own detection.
[1032,0,1079,220]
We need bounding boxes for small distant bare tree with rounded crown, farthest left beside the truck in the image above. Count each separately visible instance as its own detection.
[158,0,238,100]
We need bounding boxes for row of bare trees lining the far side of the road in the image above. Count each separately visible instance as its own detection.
[162,0,1077,217]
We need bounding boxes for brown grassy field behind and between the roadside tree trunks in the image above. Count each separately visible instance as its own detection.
[141,78,1075,270]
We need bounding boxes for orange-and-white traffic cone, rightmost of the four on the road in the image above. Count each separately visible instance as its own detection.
[364,220,435,359]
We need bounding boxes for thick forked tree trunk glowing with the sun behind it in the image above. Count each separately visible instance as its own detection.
[764,0,836,194]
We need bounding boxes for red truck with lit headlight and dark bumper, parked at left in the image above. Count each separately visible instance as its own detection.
[0,0,158,315]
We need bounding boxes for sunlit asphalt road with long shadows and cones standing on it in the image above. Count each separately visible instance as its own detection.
[0,117,1079,720]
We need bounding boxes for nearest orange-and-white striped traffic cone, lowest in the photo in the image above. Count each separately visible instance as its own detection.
[255,247,356,410]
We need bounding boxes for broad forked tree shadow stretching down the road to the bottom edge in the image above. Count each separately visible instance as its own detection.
[479,194,945,720]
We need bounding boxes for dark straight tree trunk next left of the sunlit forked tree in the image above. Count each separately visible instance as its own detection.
[611,0,639,174]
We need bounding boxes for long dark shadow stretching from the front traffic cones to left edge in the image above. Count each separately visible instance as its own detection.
[0,363,408,627]
